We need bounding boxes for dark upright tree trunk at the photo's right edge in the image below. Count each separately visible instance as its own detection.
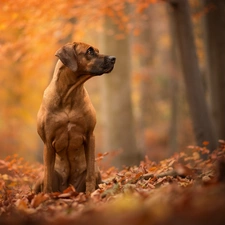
[203,0,225,139]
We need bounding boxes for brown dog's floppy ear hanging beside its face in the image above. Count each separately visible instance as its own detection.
[55,44,77,72]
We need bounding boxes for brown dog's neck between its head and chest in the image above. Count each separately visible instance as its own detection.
[44,60,91,107]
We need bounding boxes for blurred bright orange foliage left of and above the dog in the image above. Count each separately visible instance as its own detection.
[0,0,162,160]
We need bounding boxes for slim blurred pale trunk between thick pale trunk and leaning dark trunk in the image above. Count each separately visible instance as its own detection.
[132,5,157,154]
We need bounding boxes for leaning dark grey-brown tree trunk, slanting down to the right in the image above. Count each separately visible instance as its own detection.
[171,0,217,150]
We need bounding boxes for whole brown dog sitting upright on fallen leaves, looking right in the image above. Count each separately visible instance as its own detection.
[35,42,116,193]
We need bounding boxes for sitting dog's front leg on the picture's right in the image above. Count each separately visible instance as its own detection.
[85,134,96,193]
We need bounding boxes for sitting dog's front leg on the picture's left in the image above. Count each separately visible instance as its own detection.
[43,144,55,193]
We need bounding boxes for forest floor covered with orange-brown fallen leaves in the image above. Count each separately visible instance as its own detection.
[0,141,225,225]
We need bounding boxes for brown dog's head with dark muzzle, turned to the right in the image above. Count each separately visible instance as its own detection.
[55,42,116,76]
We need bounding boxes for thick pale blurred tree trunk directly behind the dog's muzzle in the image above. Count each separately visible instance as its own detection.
[102,15,140,167]
